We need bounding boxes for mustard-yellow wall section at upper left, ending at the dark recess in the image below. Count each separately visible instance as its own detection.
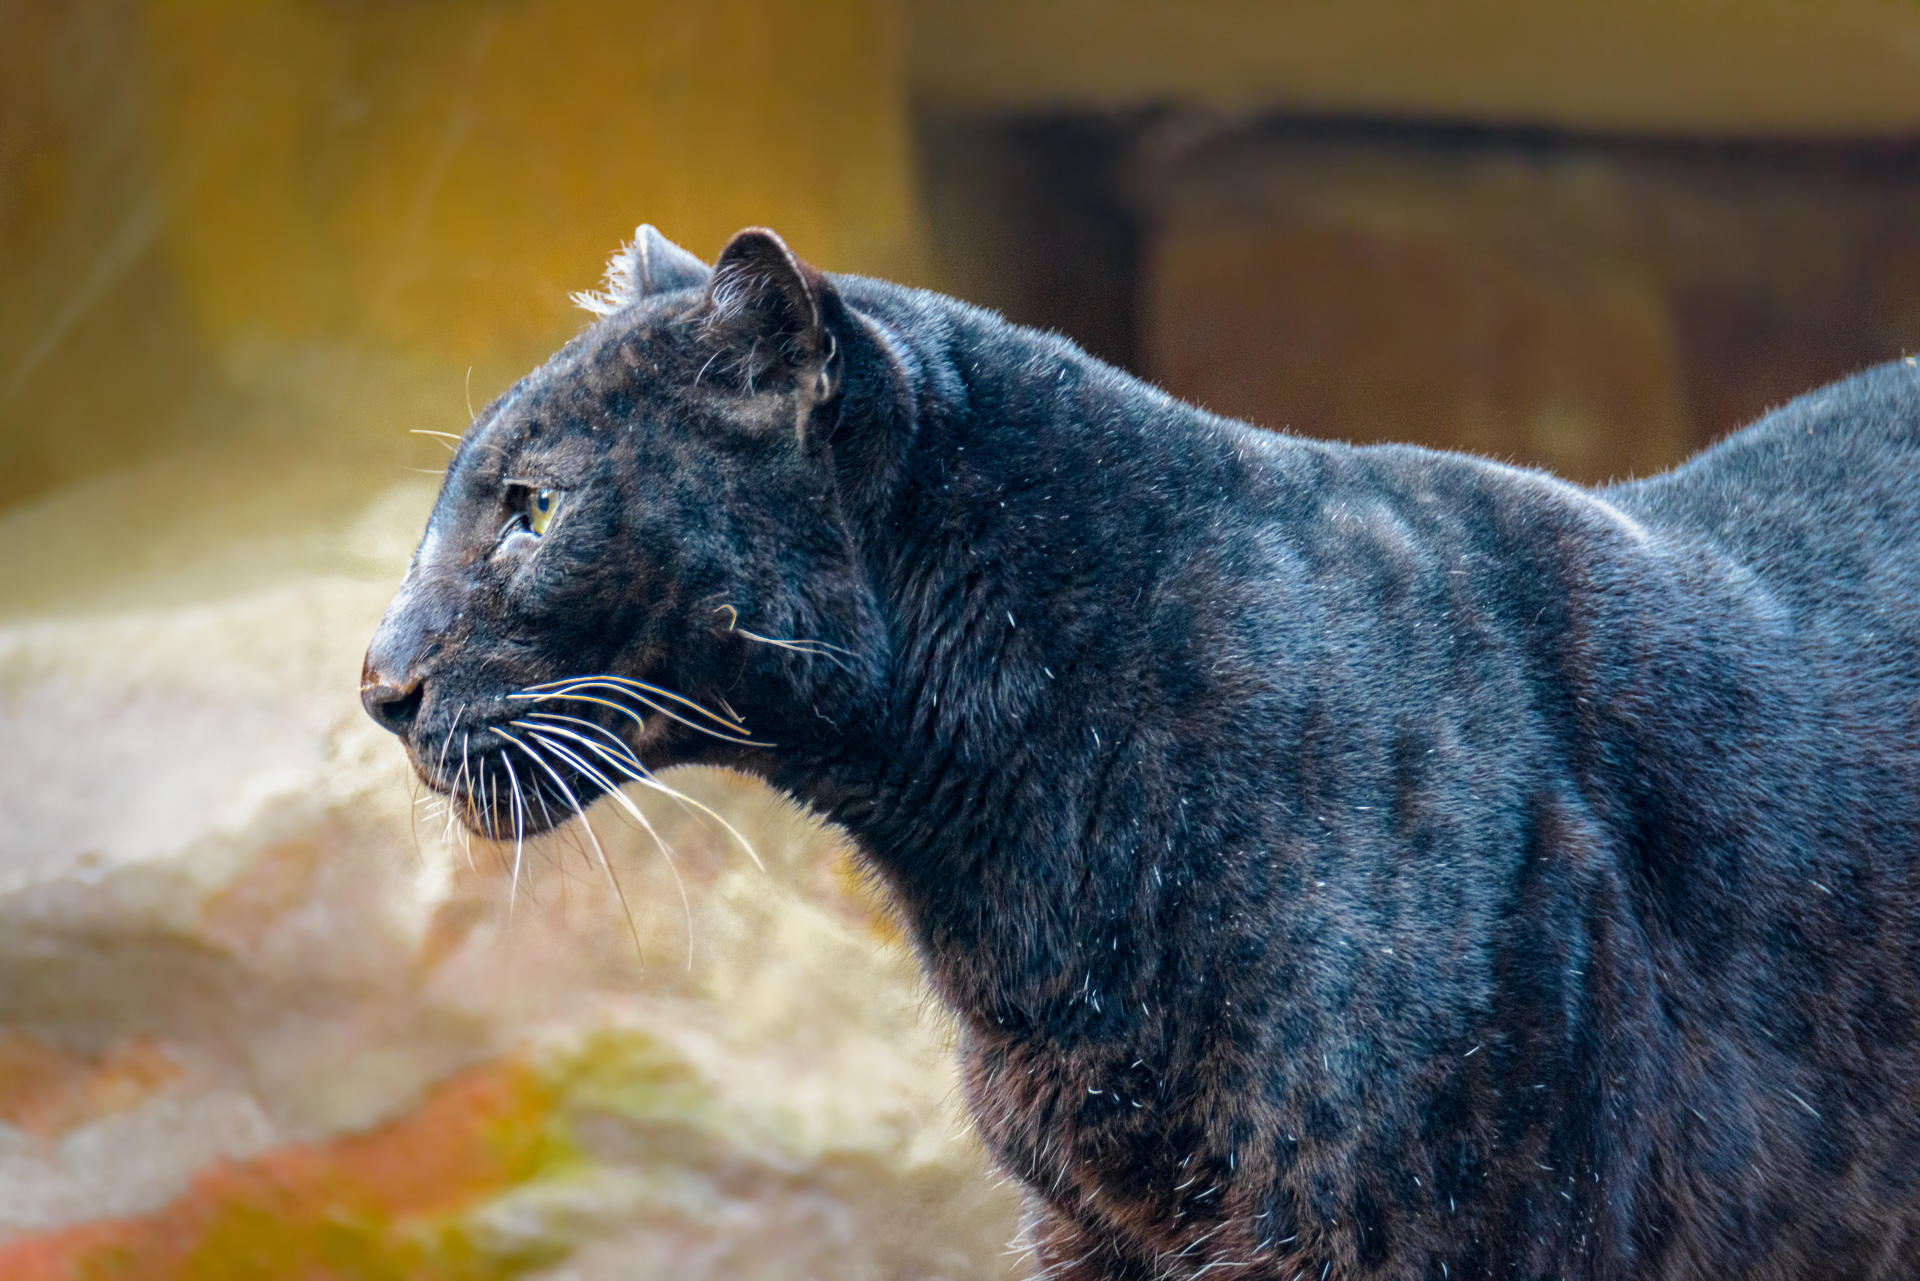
[0,0,920,505]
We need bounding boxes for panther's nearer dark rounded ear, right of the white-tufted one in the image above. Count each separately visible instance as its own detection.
[707,227,839,434]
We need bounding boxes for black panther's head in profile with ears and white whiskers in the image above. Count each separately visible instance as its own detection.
[361,227,904,837]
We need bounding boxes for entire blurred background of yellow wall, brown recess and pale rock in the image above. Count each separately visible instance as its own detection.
[0,0,1920,1279]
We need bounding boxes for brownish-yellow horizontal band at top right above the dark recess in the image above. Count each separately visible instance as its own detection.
[910,0,1920,134]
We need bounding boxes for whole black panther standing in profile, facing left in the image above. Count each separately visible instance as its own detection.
[363,229,1920,1281]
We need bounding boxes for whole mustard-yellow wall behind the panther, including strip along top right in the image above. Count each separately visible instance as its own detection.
[15,0,1920,507]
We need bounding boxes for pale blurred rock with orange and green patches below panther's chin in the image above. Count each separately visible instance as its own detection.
[0,461,1018,1281]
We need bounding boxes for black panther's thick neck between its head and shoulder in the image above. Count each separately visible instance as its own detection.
[795,311,1274,1039]
